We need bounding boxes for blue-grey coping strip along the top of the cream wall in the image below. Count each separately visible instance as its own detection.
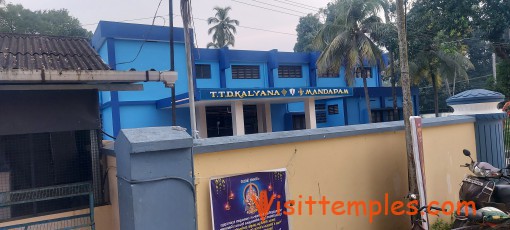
[193,116,475,154]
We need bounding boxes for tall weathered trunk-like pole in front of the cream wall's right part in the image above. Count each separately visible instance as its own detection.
[397,0,418,225]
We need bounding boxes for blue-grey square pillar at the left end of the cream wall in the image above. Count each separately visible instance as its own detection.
[115,127,196,230]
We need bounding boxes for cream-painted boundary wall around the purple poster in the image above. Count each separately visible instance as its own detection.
[194,122,475,230]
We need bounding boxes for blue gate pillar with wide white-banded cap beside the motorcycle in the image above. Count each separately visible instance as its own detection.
[446,89,507,168]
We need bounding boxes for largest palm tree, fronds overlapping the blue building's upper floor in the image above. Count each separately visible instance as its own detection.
[314,0,383,123]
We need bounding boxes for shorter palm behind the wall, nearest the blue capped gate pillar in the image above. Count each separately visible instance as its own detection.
[410,47,474,117]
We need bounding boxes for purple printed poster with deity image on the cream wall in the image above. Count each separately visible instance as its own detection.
[210,169,289,230]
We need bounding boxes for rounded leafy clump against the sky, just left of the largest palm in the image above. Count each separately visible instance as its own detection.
[294,14,322,52]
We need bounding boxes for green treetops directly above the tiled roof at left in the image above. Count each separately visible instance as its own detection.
[0,4,92,38]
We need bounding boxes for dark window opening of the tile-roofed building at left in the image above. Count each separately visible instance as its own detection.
[0,130,104,222]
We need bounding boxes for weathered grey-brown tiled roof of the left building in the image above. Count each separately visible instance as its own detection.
[0,33,109,71]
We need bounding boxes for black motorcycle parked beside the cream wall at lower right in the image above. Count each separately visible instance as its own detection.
[452,149,510,230]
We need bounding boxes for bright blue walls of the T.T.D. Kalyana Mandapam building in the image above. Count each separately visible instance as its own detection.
[92,21,417,137]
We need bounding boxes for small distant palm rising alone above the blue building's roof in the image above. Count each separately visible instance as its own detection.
[207,6,239,48]
